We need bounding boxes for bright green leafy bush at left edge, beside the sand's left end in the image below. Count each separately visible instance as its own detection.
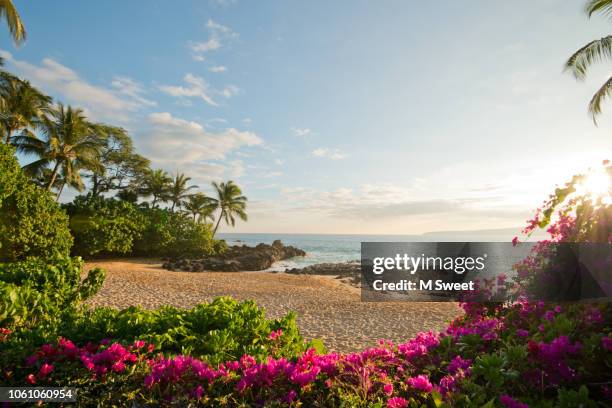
[0,256,104,328]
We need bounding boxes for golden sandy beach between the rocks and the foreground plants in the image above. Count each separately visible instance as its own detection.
[86,260,460,352]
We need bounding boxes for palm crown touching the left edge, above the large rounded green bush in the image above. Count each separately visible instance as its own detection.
[0,75,52,144]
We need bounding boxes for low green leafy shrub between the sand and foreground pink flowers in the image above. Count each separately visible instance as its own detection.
[57,297,305,363]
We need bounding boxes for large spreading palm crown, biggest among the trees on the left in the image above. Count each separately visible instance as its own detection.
[11,104,103,191]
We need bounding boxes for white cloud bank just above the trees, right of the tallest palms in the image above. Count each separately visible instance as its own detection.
[141,112,263,167]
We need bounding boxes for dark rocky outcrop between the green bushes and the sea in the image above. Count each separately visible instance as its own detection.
[162,240,306,272]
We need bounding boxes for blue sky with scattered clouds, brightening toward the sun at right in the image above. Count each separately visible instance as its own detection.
[0,0,612,234]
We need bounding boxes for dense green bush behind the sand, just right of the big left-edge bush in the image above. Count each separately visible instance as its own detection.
[64,194,145,256]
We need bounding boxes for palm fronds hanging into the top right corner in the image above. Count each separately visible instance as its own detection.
[565,0,612,124]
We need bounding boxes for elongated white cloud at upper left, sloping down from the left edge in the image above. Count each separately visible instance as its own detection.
[0,50,155,121]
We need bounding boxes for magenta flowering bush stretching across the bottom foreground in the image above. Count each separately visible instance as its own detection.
[3,301,612,407]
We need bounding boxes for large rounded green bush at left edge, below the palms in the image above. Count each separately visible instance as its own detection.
[0,145,72,262]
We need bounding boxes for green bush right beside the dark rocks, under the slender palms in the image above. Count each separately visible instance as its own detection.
[134,208,219,258]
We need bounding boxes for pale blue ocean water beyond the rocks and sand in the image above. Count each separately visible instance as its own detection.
[217,230,514,271]
